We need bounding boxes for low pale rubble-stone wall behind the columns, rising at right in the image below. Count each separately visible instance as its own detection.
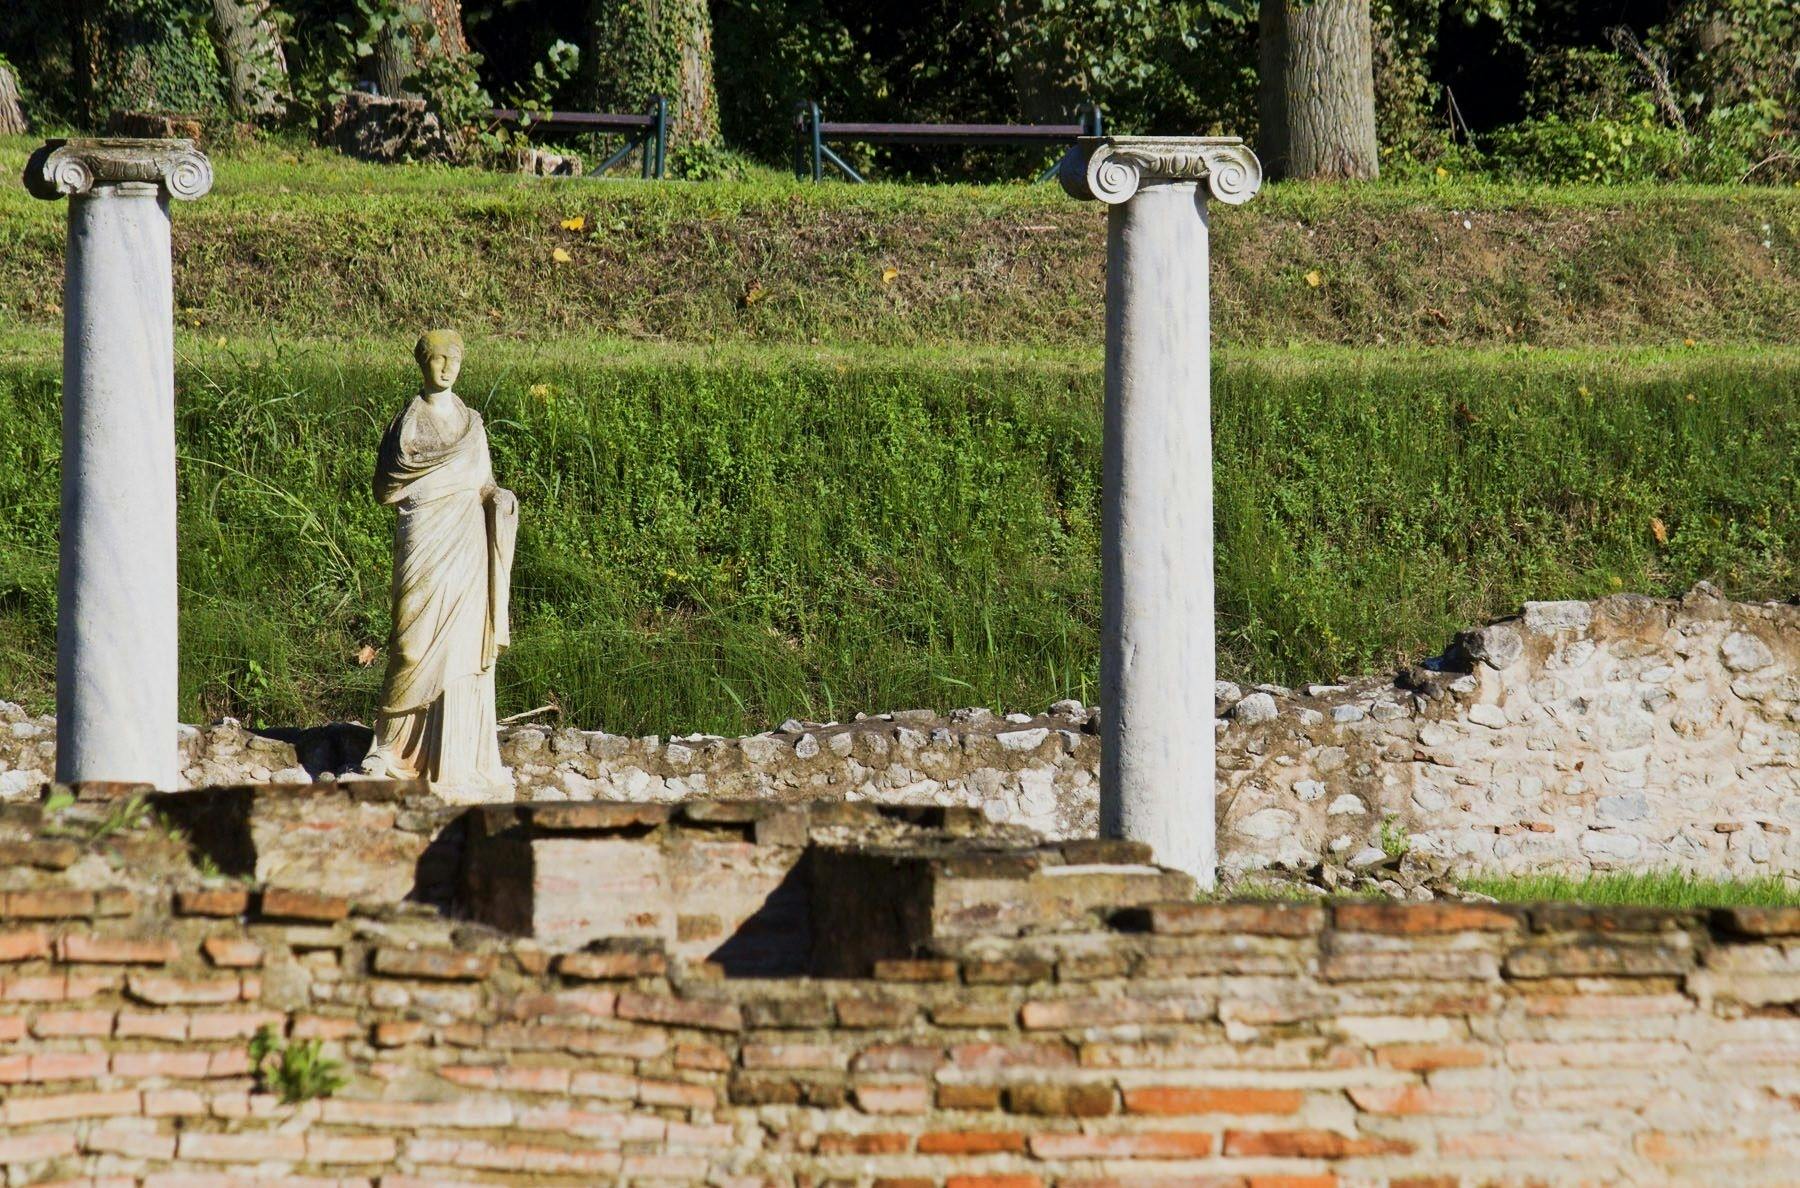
[0,585,1800,877]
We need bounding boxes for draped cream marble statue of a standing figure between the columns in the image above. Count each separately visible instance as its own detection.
[362,329,518,801]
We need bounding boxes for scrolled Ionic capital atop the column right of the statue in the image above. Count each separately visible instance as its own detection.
[1057,137,1262,205]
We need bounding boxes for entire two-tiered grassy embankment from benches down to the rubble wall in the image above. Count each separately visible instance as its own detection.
[0,140,1800,731]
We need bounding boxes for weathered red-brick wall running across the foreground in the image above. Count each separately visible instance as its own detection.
[0,792,1800,1188]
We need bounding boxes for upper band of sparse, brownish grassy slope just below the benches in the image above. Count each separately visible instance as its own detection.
[0,139,1800,347]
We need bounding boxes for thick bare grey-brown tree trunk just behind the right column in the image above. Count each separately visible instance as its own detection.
[1256,0,1381,178]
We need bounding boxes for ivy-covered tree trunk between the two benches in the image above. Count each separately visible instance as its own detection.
[581,0,718,146]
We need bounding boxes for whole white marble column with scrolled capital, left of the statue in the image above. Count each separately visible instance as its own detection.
[25,140,212,788]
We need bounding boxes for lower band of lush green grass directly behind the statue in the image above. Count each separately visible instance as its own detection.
[0,331,1800,733]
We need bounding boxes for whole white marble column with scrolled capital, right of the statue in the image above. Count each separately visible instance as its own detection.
[1060,137,1262,889]
